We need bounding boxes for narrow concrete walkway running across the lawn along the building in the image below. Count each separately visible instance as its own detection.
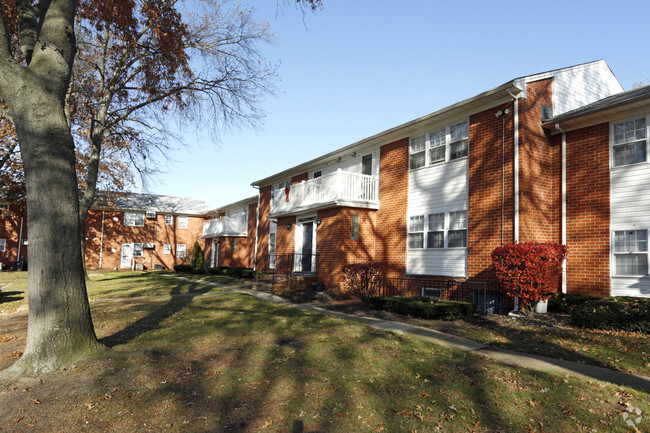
[169,275,650,394]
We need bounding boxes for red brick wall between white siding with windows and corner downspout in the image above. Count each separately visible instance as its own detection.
[467,103,514,281]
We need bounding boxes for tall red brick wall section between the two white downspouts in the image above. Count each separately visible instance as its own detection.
[519,79,562,242]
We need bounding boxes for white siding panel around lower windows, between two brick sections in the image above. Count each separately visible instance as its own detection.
[406,154,468,277]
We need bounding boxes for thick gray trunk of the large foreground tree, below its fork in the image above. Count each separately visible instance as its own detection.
[4,88,102,371]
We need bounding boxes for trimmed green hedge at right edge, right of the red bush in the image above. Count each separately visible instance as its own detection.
[571,296,650,333]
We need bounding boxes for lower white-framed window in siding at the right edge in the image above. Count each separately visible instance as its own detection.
[614,230,648,276]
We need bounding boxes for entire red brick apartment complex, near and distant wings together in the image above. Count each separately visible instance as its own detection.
[5,60,650,297]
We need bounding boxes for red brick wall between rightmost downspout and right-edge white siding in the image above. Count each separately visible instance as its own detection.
[555,123,611,296]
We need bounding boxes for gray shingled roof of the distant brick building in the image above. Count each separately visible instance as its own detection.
[97,193,210,215]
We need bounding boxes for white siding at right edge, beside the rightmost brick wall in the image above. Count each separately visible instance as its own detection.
[610,116,650,297]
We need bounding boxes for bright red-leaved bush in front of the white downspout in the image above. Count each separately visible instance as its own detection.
[492,242,567,310]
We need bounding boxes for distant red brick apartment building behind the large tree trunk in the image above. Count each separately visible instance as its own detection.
[0,194,214,270]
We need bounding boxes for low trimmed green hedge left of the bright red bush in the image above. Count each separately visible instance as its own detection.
[368,296,476,320]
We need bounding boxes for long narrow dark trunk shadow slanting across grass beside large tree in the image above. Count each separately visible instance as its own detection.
[100,282,211,347]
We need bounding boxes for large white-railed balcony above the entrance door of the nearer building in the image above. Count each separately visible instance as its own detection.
[269,169,379,218]
